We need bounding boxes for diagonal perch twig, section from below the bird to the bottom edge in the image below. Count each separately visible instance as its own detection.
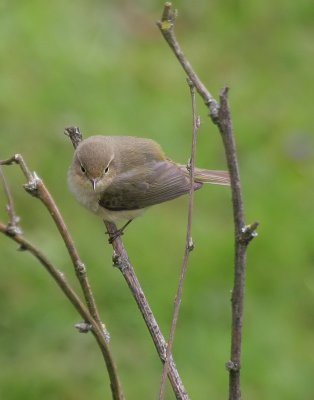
[105,221,189,400]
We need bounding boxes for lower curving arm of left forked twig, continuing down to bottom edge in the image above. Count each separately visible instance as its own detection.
[0,222,124,400]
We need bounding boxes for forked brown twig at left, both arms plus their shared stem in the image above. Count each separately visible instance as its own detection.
[0,154,124,400]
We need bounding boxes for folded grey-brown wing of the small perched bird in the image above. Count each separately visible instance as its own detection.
[99,160,202,211]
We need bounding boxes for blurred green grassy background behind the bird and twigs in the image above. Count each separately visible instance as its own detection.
[0,0,314,400]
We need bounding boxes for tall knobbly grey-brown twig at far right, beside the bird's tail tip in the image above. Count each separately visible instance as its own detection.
[157,3,258,400]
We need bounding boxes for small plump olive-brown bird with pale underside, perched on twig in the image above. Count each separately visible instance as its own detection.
[68,135,230,223]
